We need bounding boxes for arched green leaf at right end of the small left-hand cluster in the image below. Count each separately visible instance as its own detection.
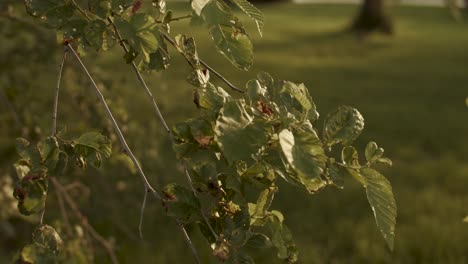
[74,132,112,158]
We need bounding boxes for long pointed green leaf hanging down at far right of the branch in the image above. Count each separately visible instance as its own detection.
[360,168,397,250]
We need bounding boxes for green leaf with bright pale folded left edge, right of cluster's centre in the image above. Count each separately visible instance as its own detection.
[278,129,327,192]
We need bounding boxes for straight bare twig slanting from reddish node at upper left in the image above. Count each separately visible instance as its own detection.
[67,44,162,200]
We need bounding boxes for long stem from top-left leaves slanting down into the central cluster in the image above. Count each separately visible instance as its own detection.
[107,18,218,239]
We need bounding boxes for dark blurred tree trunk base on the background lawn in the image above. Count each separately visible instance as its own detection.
[351,0,394,35]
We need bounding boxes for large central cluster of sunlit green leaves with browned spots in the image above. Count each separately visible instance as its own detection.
[165,72,396,263]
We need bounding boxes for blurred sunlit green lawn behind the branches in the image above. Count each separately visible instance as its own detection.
[2,3,468,263]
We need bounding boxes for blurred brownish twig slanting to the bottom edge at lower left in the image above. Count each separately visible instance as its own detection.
[51,177,119,264]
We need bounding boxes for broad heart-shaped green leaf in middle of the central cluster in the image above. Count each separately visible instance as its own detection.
[215,101,270,164]
